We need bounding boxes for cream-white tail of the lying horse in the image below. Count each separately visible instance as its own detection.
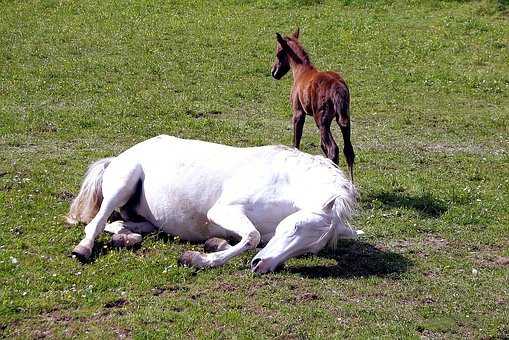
[66,158,113,224]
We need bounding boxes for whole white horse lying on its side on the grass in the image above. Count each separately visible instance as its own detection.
[67,135,362,273]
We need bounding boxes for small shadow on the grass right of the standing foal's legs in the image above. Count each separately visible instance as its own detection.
[362,191,447,218]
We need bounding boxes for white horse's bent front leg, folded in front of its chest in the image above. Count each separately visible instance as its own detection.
[179,205,260,268]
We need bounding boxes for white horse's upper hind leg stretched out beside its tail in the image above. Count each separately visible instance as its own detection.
[72,165,140,260]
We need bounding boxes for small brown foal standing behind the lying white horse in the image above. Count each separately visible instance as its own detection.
[271,29,355,182]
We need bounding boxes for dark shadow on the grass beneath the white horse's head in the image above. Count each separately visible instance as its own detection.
[286,240,413,278]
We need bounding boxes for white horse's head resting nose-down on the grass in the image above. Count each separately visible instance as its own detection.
[251,210,332,274]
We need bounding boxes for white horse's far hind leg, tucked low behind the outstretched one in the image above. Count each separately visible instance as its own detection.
[104,221,156,248]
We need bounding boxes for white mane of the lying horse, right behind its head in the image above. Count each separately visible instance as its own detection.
[329,182,364,249]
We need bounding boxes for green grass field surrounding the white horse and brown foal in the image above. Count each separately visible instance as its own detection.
[0,0,509,339]
